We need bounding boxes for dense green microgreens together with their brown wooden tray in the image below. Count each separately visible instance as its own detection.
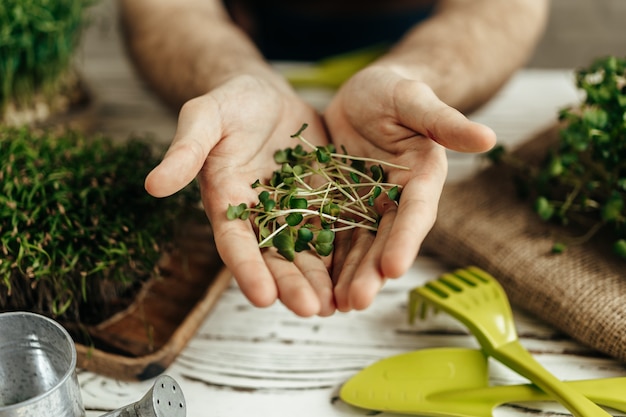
[0,126,230,380]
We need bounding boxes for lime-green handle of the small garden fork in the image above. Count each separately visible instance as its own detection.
[488,340,610,417]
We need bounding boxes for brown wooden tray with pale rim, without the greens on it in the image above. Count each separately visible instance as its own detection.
[76,221,231,380]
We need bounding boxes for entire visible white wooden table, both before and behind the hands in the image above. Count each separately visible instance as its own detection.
[79,5,626,417]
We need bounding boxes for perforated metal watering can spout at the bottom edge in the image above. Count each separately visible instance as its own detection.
[101,375,187,417]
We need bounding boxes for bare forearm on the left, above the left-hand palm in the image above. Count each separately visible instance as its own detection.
[120,0,287,106]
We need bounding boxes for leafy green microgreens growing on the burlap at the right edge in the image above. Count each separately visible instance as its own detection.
[490,56,626,258]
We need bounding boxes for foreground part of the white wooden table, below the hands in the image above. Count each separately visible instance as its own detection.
[79,254,626,417]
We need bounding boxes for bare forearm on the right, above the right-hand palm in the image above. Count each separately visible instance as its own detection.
[378,0,548,112]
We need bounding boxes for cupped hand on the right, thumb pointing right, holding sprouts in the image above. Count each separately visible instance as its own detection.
[324,66,495,311]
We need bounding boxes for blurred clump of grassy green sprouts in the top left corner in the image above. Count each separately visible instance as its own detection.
[0,0,95,113]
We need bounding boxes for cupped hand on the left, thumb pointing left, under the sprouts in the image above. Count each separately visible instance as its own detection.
[146,76,335,316]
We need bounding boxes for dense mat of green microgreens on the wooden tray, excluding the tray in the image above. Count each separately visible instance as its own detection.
[0,127,202,323]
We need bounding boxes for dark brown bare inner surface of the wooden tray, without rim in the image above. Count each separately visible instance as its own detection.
[68,218,222,357]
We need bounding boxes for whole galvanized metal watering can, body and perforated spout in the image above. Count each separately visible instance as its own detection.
[0,312,187,417]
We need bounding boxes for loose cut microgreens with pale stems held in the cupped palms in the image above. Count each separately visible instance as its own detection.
[227,124,408,261]
